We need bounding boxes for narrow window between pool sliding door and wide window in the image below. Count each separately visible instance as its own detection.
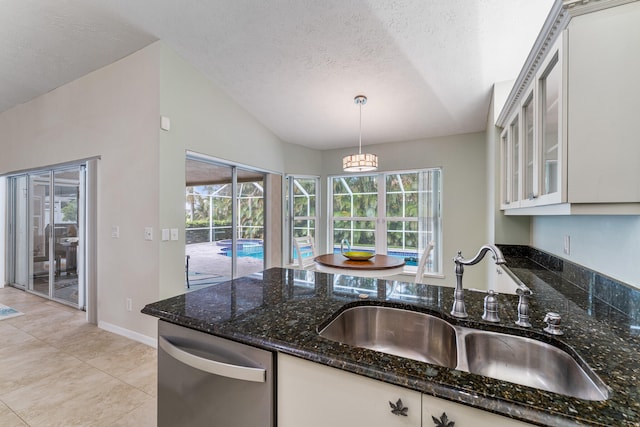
[287,176,318,263]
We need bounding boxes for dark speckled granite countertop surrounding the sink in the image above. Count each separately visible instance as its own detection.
[142,247,640,426]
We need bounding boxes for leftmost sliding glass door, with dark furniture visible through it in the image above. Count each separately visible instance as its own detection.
[8,165,85,308]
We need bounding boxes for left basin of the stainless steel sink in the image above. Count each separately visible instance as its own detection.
[320,306,458,368]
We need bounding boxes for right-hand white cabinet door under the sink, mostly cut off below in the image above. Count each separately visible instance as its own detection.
[422,395,532,427]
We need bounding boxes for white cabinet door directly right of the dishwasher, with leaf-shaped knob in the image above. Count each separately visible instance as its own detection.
[277,354,422,427]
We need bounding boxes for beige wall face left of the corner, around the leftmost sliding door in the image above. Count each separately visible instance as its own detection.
[0,46,159,342]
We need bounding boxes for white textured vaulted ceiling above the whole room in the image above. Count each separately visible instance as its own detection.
[0,0,553,149]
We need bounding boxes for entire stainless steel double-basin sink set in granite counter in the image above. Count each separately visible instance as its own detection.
[319,305,609,401]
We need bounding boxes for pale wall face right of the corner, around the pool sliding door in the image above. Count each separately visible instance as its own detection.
[159,45,321,298]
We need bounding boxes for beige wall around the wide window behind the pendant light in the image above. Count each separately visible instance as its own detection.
[321,132,489,288]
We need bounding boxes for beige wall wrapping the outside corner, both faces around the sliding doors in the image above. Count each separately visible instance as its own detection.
[0,42,321,342]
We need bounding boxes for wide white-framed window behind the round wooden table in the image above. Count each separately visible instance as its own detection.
[329,169,441,274]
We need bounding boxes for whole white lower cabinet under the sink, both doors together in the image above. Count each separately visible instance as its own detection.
[277,354,531,427]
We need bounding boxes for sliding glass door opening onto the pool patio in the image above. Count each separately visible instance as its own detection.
[185,158,265,289]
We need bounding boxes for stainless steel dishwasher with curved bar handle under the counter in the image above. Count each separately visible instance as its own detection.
[158,320,274,427]
